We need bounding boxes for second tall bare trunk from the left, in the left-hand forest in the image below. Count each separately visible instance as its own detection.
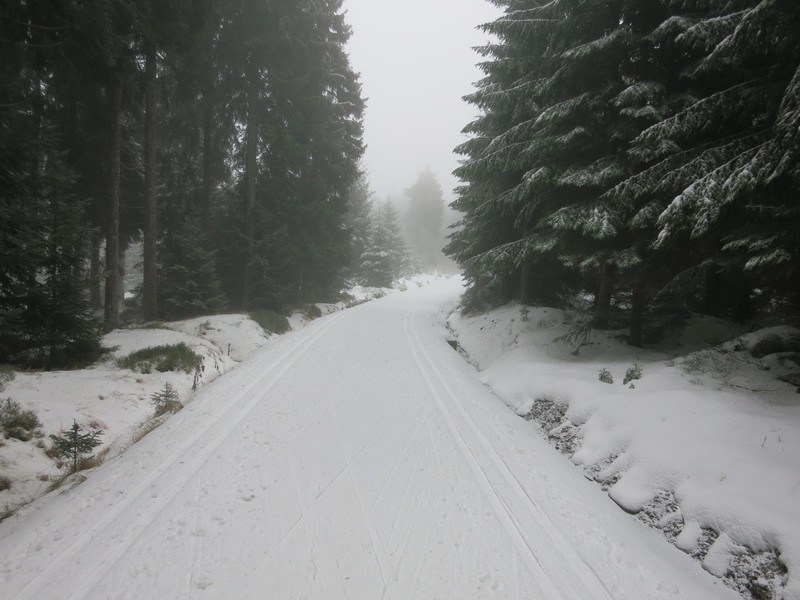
[142,43,158,321]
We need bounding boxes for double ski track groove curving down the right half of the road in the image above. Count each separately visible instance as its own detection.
[403,309,613,600]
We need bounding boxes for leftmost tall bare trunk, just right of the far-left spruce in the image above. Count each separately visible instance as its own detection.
[105,79,122,329]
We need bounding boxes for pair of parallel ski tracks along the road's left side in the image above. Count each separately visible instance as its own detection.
[16,312,348,600]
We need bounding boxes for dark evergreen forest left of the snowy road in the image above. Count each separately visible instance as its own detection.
[0,0,364,367]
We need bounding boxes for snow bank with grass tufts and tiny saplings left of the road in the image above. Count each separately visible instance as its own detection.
[0,315,268,511]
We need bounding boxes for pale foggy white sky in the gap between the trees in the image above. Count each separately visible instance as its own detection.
[344,0,500,202]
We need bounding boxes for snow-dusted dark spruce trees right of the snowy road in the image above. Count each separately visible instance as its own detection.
[446,0,800,345]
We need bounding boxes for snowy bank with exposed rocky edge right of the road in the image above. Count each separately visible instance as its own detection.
[449,306,800,600]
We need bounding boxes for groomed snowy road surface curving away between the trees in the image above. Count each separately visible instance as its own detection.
[0,281,738,600]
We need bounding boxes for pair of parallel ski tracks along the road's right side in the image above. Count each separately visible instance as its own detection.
[403,309,614,600]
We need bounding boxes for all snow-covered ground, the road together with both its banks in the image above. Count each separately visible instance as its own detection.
[0,277,800,600]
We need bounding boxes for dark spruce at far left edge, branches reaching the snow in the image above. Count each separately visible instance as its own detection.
[0,2,99,368]
